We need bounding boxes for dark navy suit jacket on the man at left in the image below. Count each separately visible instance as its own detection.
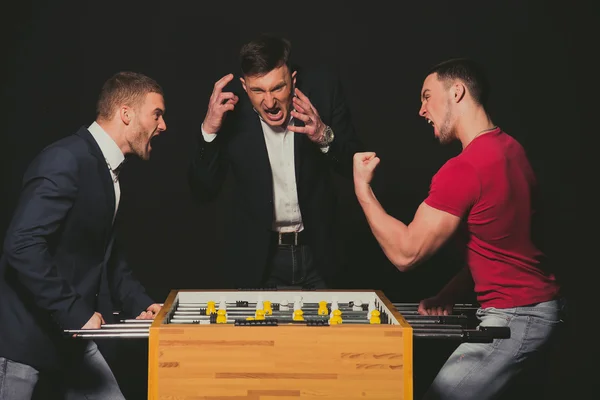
[0,127,153,369]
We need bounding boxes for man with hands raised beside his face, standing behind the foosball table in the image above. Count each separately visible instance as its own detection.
[189,34,362,288]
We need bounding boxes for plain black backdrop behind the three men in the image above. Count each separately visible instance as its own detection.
[0,1,593,400]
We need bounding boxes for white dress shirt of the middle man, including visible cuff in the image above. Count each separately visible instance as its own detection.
[202,118,304,232]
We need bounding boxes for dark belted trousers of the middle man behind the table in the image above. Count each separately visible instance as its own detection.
[265,245,326,289]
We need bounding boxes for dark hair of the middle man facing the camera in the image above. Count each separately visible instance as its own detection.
[240,33,292,76]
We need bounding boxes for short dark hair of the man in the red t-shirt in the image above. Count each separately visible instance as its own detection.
[427,58,490,107]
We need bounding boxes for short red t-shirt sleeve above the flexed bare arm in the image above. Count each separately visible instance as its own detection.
[425,159,480,217]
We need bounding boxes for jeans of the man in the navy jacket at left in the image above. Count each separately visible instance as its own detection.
[0,339,125,400]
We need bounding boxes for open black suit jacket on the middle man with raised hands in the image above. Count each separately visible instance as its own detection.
[189,68,362,287]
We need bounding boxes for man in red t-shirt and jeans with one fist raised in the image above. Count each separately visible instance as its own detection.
[354,59,563,399]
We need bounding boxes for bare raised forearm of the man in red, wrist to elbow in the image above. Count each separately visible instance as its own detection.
[356,185,419,271]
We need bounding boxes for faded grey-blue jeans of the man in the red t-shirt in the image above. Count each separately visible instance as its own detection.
[424,300,564,400]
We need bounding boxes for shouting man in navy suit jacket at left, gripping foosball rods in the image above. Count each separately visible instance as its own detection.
[0,72,166,400]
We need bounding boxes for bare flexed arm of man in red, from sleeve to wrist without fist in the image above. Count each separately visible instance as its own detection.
[357,185,460,271]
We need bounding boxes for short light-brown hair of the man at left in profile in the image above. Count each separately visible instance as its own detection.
[96,71,163,119]
